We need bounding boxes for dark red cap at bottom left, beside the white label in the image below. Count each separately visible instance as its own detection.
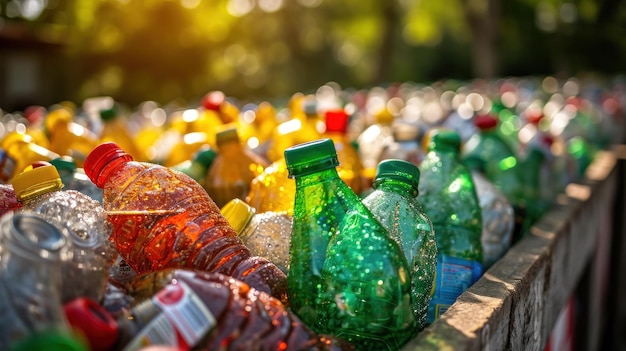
[63,297,119,351]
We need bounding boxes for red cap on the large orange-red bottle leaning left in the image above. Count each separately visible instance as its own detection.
[83,142,133,188]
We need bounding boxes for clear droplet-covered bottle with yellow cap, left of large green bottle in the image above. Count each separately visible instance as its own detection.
[221,199,291,274]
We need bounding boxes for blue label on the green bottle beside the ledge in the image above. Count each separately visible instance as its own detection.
[427,254,483,324]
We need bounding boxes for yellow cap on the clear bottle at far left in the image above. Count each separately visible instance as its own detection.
[11,165,63,201]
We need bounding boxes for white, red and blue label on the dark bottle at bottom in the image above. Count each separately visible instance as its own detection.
[124,281,216,351]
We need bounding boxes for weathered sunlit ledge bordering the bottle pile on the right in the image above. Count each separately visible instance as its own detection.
[403,148,623,351]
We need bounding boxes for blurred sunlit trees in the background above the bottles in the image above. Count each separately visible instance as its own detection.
[0,0,626,108]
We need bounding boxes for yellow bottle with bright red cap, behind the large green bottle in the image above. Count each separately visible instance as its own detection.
[323,109,365,195]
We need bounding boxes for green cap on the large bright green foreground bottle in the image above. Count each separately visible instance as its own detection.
[285,138,339,178]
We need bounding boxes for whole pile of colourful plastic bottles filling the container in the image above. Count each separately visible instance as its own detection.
[0,77,626,351]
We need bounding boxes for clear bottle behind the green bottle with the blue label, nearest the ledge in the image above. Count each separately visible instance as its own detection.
[463,156,515,271]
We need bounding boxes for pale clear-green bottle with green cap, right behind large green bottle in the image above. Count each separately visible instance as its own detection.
[363,159,437,330]
